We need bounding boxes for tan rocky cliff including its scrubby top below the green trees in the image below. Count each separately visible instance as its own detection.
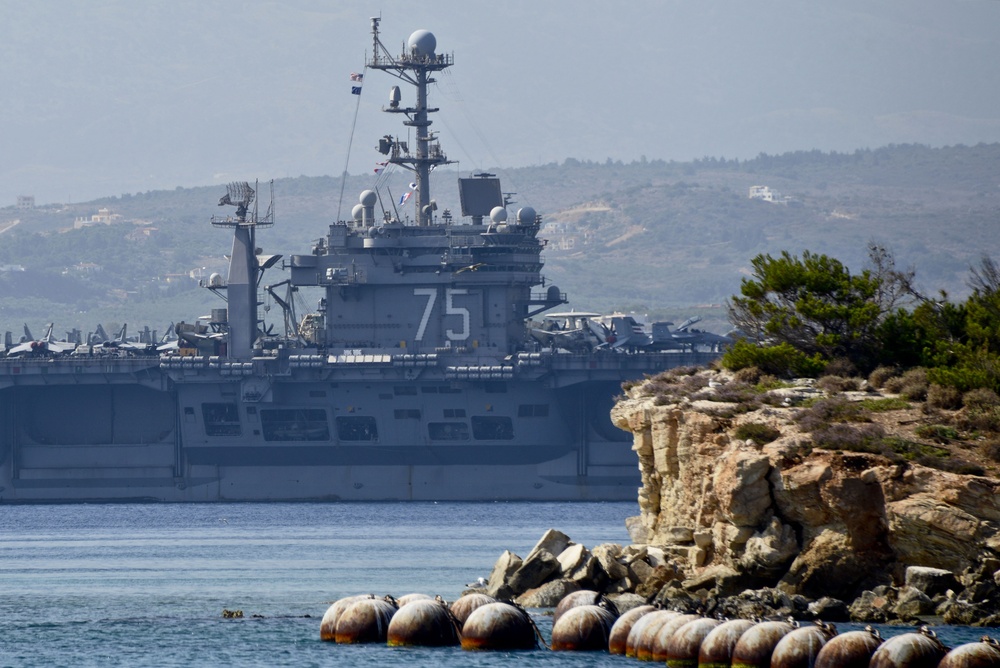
[612,370,1000,600]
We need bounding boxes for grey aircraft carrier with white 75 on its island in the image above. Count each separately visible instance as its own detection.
[0,19,718,503]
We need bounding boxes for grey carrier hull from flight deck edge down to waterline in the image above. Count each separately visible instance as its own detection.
[0,353,714,503]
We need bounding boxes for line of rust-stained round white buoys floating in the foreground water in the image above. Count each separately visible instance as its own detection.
[320,590,1000,668]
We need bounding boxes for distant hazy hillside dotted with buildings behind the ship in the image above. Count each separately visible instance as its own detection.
[0,144,1000,331]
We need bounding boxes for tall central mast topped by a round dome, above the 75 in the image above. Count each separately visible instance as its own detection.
[368,17,454,226]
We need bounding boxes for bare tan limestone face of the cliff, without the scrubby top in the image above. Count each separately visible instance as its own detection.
[612,372,1000,600]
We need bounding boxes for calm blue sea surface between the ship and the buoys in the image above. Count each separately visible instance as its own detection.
[0,503,981,668]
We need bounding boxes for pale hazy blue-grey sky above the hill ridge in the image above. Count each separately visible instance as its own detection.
[0,0,1000,206]
